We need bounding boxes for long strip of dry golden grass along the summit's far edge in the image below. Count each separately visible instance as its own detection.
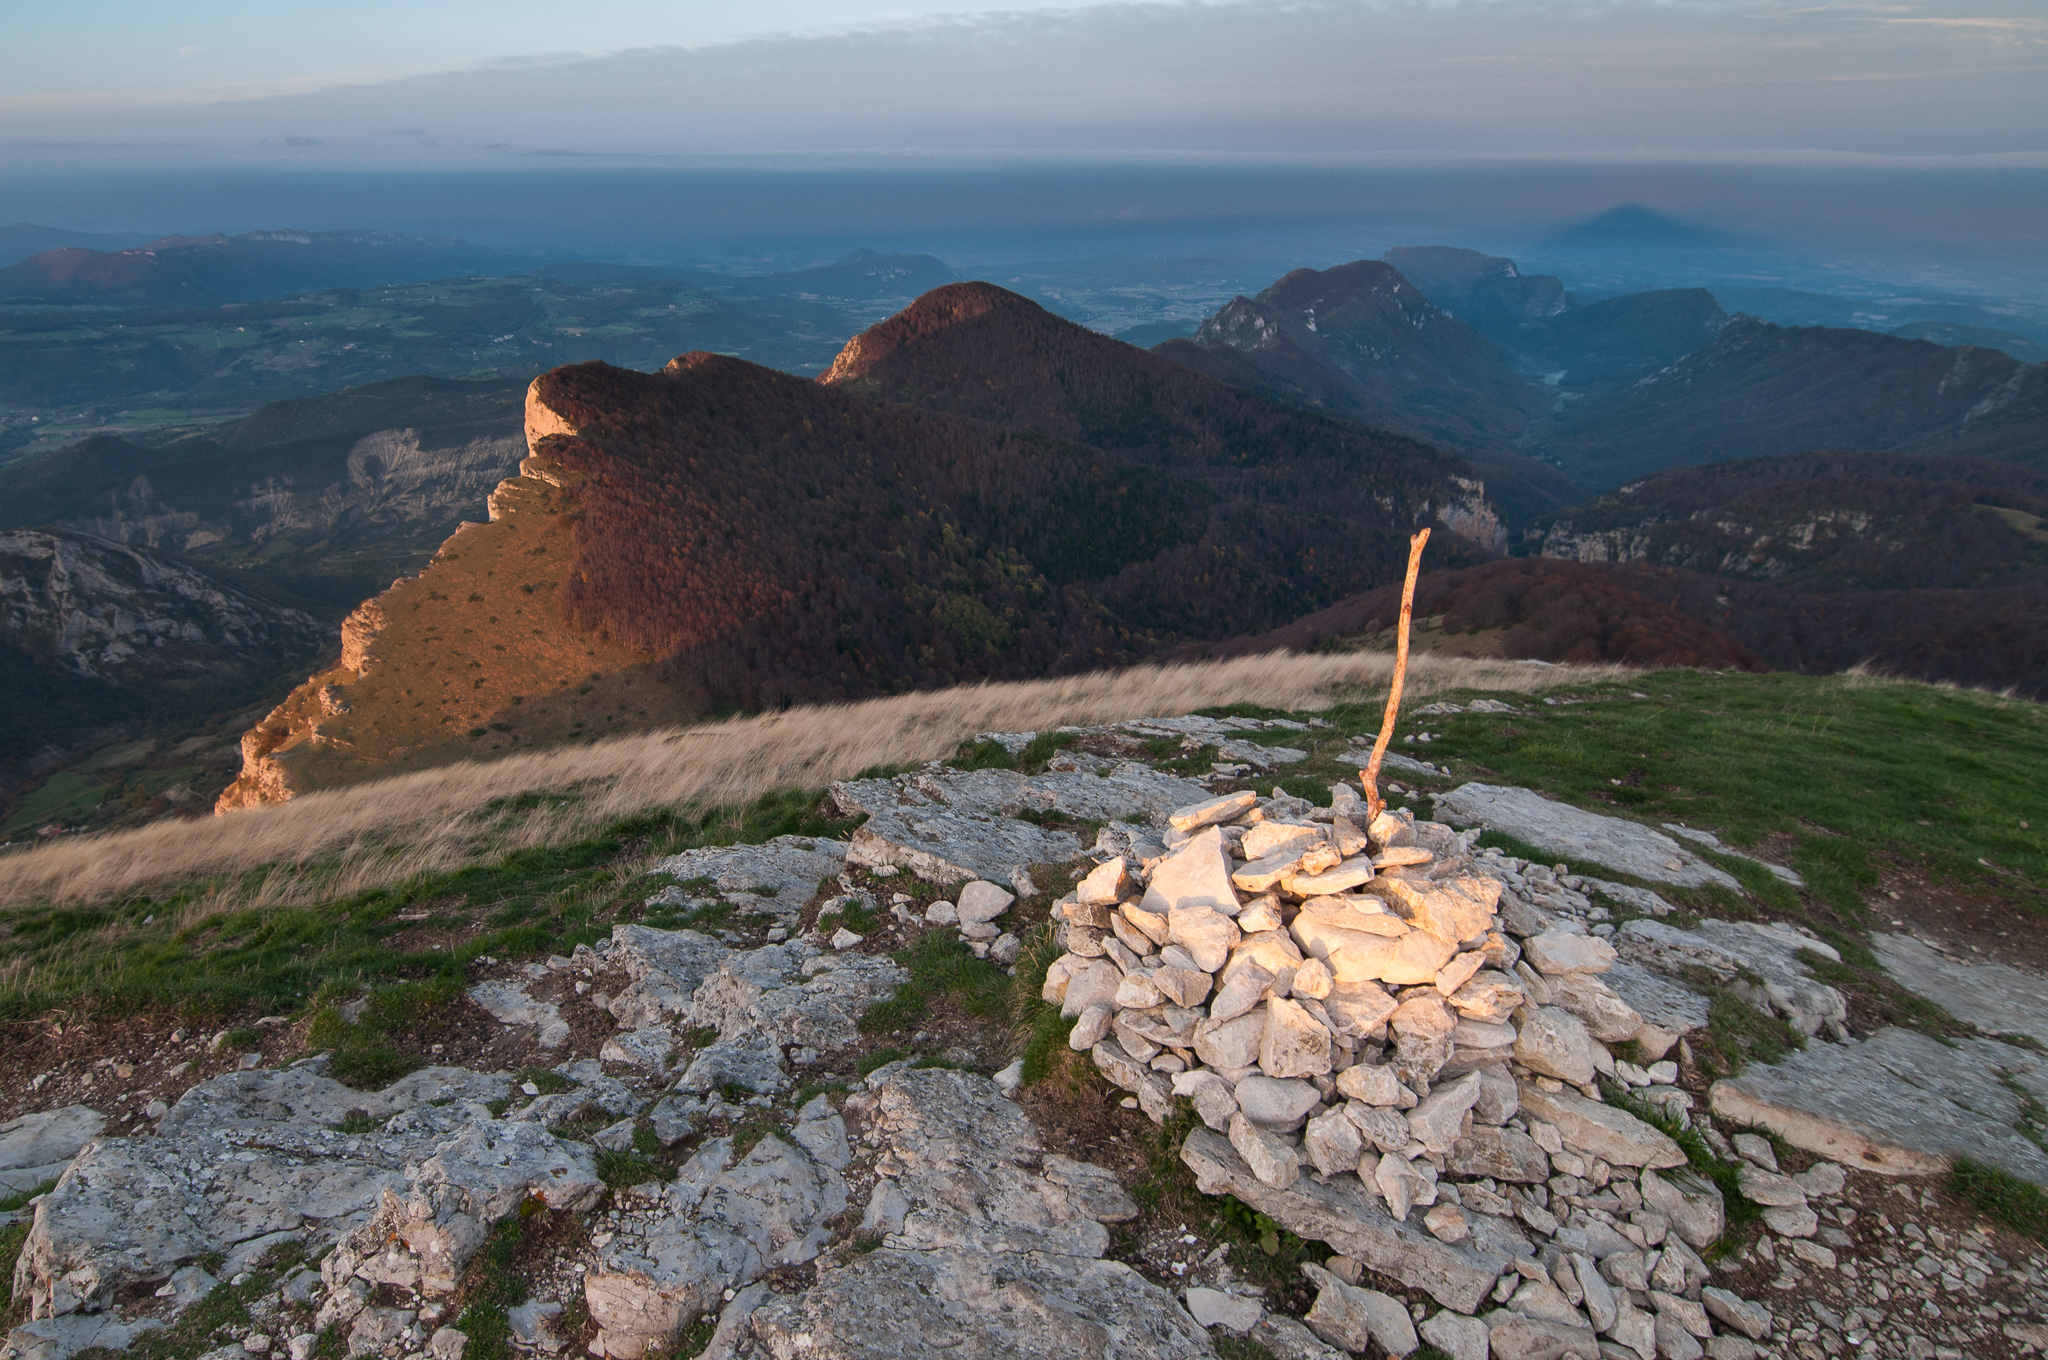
[0,653,1624,920]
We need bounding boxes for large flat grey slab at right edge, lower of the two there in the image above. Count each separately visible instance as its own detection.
[1710,1028,2048,1186]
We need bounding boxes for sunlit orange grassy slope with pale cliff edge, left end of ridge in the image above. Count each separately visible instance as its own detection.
[215,383,686,813]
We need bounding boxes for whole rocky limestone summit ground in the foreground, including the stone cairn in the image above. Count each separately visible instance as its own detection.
[0,717,2048,1360]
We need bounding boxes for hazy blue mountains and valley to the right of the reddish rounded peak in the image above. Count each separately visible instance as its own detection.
[1157,246,2048,503]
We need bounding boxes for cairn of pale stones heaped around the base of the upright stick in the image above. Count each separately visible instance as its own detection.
[1044,784,1785,1360]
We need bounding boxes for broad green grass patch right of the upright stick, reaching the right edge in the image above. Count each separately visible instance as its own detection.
[1303,670,2048,920]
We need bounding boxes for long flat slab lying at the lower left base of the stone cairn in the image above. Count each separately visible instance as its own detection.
[1180,1129,1534,1313]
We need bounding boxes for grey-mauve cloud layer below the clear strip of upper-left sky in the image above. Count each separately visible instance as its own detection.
[0,0,2048,164]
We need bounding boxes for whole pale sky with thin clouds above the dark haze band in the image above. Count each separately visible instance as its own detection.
[12,0,2048,172]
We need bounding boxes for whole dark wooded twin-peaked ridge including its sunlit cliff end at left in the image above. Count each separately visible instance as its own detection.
[219,285,1503,811]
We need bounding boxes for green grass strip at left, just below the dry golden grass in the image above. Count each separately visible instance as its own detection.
[0,789,854,1028]
